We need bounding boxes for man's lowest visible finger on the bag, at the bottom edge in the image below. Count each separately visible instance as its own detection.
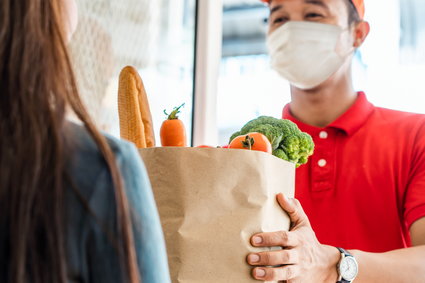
[252,265,300,281]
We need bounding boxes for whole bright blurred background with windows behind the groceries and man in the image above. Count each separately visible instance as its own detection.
[70,0,425,145]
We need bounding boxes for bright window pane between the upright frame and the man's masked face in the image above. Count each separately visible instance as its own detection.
[217,0,274,144]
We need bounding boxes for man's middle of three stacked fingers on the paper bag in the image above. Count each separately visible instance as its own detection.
[247,250,298,266]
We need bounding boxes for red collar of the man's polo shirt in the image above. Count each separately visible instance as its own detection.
[282,92,374,135]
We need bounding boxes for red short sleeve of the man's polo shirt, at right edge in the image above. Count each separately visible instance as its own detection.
[404,119,425,228]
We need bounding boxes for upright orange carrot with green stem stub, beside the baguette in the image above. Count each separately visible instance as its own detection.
[160,103,187,146]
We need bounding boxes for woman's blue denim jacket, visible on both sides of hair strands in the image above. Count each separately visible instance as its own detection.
[66,124,171,283]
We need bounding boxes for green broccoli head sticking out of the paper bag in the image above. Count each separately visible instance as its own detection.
[230,116,314,167]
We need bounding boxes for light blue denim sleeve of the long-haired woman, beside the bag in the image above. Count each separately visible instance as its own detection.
[119,143,171,283]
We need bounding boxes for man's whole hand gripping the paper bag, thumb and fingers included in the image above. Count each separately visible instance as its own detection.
[247,194,340,283]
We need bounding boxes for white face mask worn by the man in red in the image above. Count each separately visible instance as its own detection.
[267,21,354,89]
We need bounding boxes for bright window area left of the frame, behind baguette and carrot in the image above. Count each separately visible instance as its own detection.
[70,0,196,143]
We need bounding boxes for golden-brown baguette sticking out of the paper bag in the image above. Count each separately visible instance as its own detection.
[118,66,155,148]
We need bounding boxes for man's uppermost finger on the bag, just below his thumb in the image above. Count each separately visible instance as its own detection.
[251,231,298,247]
